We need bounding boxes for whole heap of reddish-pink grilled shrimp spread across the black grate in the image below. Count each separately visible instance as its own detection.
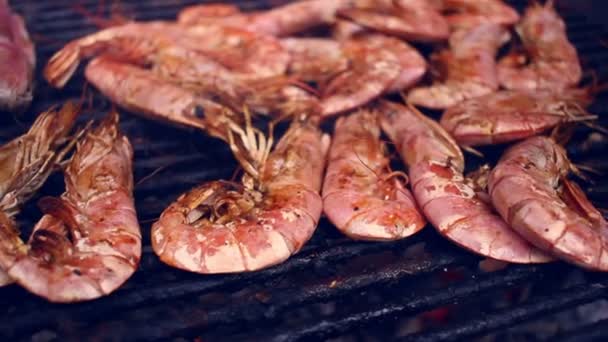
[0,0,608,302]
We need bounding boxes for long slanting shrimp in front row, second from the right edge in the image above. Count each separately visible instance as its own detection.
[379,101,550,263]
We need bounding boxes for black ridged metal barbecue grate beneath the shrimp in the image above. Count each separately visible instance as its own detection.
[0,0,608,341]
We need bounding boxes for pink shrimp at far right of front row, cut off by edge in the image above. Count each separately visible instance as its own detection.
[489,137,608,271]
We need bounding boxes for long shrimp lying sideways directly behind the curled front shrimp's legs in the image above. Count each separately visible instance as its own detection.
[85,53,319,123]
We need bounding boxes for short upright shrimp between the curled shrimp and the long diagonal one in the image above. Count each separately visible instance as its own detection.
[323,109,425,241]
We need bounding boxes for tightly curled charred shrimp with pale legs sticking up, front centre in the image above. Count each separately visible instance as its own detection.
[152,113,329,273]
